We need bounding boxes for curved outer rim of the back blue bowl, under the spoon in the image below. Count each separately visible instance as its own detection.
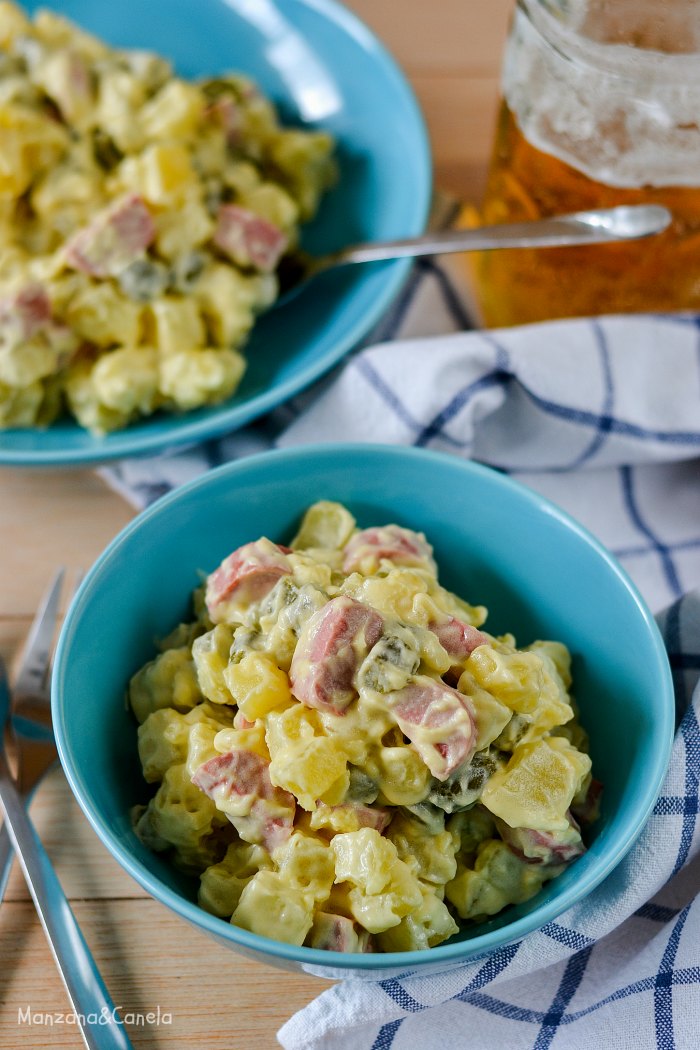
[0,0,432,467]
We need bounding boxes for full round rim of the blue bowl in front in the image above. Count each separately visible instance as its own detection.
[51,442,675,965]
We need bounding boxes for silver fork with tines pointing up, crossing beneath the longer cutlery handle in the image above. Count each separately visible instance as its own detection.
[0,568,67,903]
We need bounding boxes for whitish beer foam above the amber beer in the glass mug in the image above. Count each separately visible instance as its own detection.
[503,8,700,188]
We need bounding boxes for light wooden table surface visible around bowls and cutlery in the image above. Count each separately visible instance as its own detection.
[0,0,512,1050]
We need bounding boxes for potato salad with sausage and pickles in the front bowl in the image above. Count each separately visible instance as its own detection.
[129,502,600,951]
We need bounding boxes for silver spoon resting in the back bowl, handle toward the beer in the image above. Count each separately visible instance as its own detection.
[277,204,673,303]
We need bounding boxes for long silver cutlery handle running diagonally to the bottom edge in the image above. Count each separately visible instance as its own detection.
[0,743,132,1050]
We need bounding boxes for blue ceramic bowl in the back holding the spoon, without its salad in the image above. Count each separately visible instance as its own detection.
[0,0,431,466]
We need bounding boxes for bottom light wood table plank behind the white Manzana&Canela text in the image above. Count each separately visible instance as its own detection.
[0,898,330,1050]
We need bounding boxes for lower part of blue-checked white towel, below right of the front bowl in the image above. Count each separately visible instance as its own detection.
[278,591,700,1050]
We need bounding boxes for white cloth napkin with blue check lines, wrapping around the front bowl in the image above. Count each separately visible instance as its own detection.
[102,260,700,1050]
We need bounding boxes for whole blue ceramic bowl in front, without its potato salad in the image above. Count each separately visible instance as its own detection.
[54,445,674,980]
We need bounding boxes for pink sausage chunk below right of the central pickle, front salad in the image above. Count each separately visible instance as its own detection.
[386,675,476,780]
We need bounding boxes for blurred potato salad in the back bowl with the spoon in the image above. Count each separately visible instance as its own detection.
[0,0,334,435]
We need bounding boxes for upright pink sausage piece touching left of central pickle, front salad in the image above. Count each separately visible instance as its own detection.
[290,595,384,714]
